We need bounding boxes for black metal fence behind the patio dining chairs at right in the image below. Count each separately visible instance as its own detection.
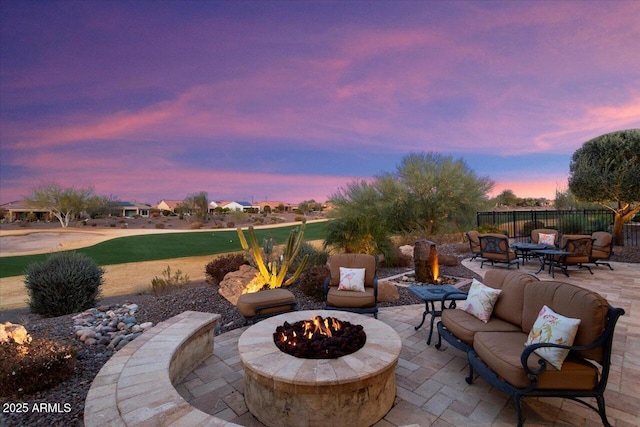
[476,209,640,246]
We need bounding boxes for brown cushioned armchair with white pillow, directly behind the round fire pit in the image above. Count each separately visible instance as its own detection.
[324,254,378,319]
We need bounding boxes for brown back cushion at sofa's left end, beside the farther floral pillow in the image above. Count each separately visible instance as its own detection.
[484,269,538,326]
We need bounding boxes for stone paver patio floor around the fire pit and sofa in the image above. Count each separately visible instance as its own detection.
[176,259,640,427]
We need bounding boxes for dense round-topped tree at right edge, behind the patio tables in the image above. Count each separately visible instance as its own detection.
[569,129,640,246]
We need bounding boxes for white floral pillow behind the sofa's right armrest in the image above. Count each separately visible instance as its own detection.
[524,305,580,370]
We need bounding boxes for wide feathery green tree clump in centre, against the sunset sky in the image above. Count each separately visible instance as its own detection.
[325,152,493,255]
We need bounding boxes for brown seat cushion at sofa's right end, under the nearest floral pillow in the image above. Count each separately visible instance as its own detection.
[473,332,598,390]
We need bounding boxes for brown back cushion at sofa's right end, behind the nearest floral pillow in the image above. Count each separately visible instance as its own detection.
[524,281,609,361]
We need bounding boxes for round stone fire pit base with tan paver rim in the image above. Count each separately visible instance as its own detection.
[238,310,402,426]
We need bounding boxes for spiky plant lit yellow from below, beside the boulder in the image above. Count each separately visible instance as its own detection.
[238,220,309,289]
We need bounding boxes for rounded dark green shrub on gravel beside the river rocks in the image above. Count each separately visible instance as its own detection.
[24,252,104,317]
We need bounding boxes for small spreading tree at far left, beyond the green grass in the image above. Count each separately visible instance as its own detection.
[25,183,109,228]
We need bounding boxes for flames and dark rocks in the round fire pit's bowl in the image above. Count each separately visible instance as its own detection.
[273,316,367,359]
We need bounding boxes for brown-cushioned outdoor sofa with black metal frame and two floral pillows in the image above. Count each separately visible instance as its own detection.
[436,269,624,426]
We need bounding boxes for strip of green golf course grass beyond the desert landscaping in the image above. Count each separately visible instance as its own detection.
[0,222,325,278]
